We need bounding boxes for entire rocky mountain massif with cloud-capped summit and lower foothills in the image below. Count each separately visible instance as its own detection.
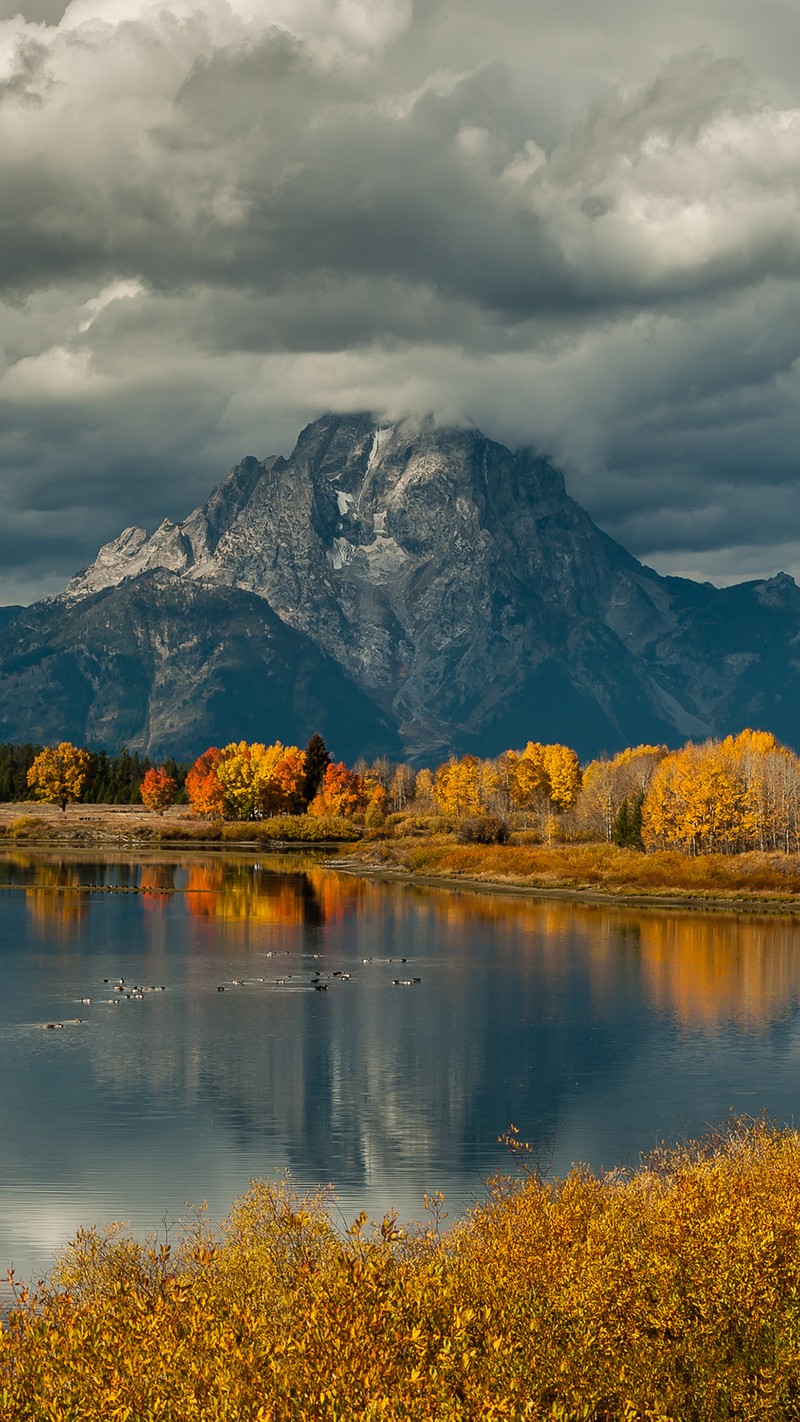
[0,414,800,762]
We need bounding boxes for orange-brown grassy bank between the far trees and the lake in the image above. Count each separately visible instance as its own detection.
[7,803,800,914]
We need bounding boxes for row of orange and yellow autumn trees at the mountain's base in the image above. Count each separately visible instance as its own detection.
[17,729,800,855]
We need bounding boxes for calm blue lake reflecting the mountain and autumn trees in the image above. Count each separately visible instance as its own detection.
[0,852,800,1280]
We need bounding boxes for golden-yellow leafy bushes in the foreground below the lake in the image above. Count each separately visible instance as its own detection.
[0,1122,800,1422]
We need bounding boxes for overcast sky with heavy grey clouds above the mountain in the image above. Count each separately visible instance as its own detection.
[0,0,800,603]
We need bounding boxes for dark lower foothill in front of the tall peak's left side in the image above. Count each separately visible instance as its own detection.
[0,570,401,759]
